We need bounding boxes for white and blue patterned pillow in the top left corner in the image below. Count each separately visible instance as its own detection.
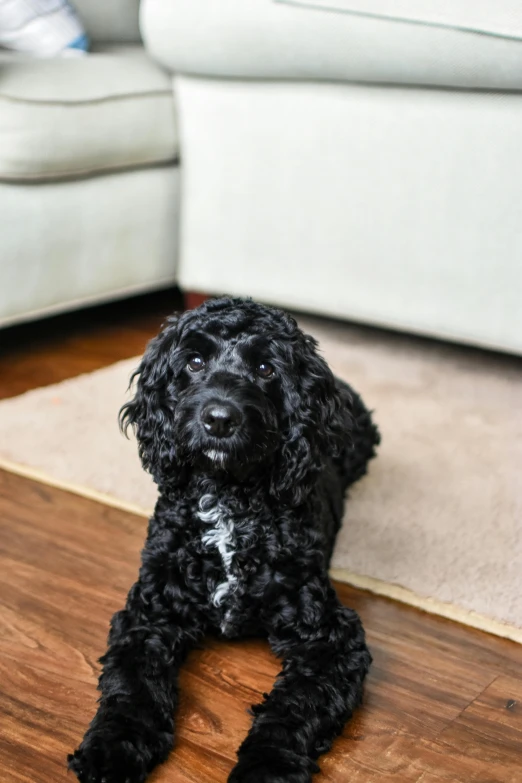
[0,0,88,57]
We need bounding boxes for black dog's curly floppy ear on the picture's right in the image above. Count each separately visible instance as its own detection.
[271,335,351,505]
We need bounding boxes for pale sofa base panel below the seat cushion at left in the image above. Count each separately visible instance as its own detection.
[0,165,179,326]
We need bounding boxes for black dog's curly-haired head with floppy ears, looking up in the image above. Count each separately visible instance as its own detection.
[120,298,349,503]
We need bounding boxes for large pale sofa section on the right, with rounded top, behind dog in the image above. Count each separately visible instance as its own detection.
[141,0,522,353]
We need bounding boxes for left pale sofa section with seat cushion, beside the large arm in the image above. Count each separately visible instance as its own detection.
[0,0,179,326]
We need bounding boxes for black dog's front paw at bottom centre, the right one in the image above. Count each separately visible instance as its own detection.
[228,746,319,783]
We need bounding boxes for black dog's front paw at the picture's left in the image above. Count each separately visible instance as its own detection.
[67,735,147,783]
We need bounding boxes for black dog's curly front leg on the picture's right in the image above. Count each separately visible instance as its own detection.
[229,574,371,783]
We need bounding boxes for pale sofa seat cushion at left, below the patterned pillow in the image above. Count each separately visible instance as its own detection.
[0,46,178,181]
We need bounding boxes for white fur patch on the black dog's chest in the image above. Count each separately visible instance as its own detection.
[198,495,237,606]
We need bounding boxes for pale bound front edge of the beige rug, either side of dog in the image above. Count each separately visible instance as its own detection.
[0,457,522,644]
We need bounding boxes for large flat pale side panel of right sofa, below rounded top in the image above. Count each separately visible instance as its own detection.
[176,77,522,353]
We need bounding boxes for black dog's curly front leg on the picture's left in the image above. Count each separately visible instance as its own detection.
[69,524,205,783]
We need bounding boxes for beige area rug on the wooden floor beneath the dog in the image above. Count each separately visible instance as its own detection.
[0,319,522,642]
